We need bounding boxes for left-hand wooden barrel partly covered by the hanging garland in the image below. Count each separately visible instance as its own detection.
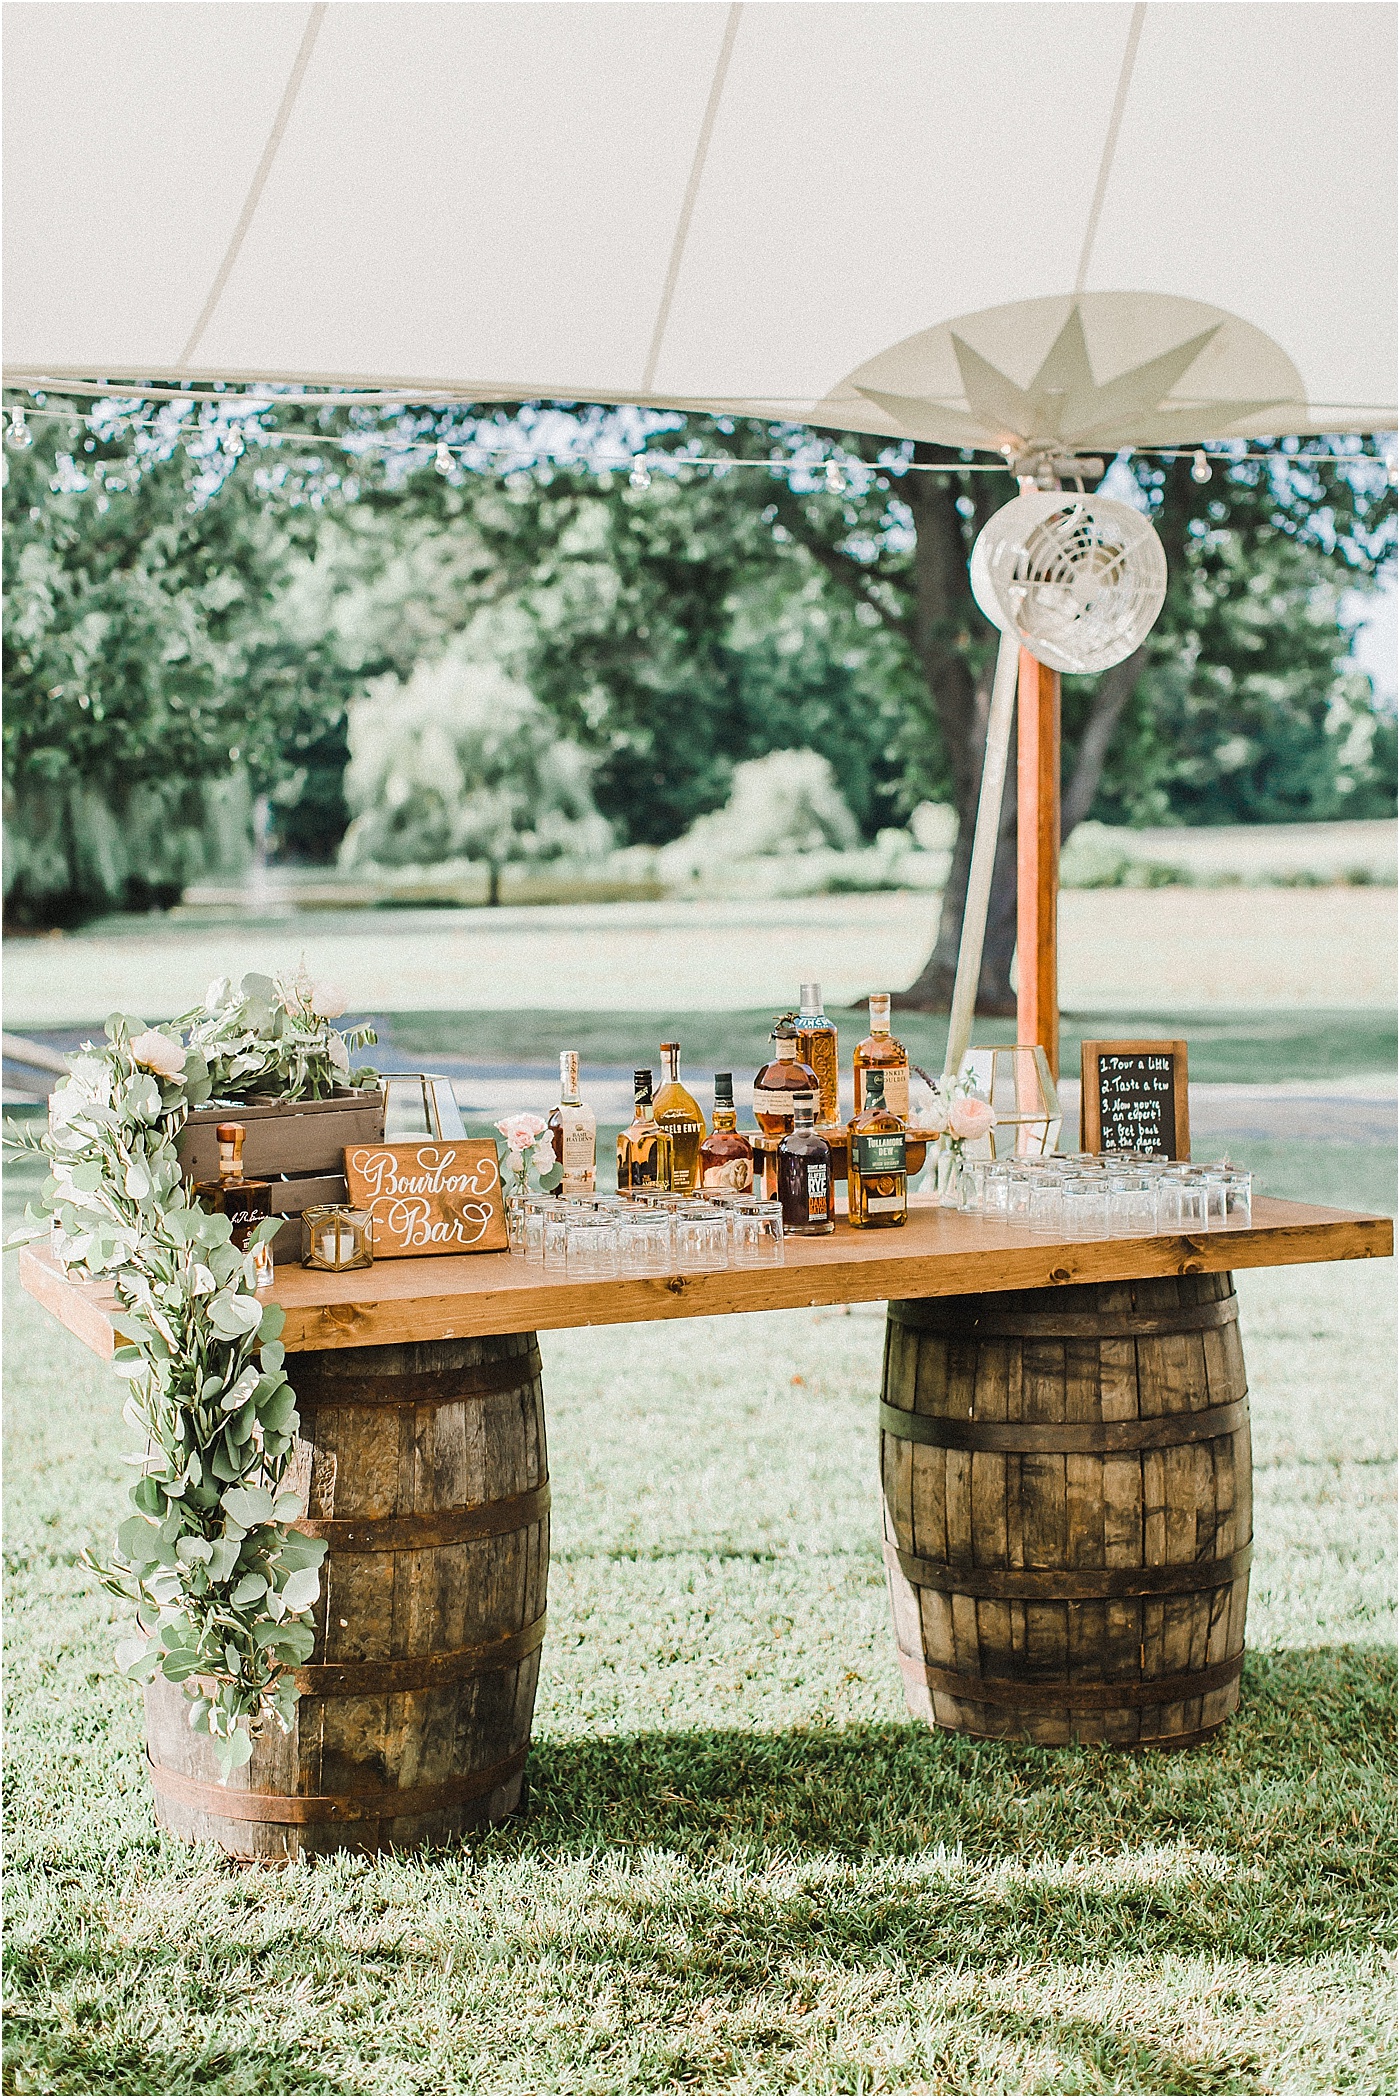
[147,1332,550,1859]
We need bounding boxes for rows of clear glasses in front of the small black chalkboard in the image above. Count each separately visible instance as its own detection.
[959,1152,1253,1238]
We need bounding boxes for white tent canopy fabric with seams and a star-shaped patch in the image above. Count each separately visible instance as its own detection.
[4,0,1396,445]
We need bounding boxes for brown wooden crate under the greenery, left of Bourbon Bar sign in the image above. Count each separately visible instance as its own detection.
[176,1085,384,1261]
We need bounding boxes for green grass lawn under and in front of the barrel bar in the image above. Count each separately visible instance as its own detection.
[4,1116,1394,2094]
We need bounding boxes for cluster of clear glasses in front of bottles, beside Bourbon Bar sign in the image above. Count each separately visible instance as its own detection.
[521,1196,783,1280]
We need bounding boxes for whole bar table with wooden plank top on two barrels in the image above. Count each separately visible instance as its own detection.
[21,1198,1392,1857]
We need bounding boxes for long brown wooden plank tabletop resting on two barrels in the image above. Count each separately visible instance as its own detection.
[19,1198,1394,1355]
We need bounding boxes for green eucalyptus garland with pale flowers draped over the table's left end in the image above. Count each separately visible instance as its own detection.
[13,969,374,1777]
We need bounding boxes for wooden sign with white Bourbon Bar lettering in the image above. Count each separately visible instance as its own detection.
[344,1137,506,1261]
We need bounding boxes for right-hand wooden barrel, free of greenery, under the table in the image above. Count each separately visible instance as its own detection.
[879,1276,1253,1748]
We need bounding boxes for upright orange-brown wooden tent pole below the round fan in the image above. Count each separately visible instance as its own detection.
[1016,648,1060,1078]
